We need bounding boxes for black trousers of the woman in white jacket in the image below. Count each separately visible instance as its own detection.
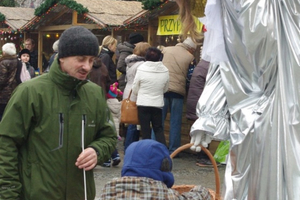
[138,106,166,145]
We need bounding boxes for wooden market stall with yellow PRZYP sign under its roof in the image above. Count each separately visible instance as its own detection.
[124,0,206,46]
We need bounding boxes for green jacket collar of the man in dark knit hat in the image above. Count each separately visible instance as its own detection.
[49,58,87,91]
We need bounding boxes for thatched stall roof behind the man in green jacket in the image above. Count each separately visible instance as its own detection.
[21,0,143,30]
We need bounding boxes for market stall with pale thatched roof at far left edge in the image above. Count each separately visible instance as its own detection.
[0,7,34,55]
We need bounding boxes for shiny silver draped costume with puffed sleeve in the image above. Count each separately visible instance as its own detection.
[191,0,300,200]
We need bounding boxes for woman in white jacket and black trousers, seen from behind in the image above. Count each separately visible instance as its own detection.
[132,47,169,145]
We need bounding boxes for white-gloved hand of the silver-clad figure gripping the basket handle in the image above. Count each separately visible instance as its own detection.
[190,131,213,152]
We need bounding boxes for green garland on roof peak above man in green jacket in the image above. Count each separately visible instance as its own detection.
[34,0,89,16]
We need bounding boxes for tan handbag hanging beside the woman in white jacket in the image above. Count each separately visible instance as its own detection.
[121,90,139,124]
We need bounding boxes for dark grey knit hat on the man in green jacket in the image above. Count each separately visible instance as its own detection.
[58,26,99,58]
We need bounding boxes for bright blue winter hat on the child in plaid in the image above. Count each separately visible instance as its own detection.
[121,139,174,188]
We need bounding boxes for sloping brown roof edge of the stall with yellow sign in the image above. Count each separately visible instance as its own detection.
[124,1,179,26]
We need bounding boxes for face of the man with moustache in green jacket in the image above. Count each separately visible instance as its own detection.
[59,56,95,80]
